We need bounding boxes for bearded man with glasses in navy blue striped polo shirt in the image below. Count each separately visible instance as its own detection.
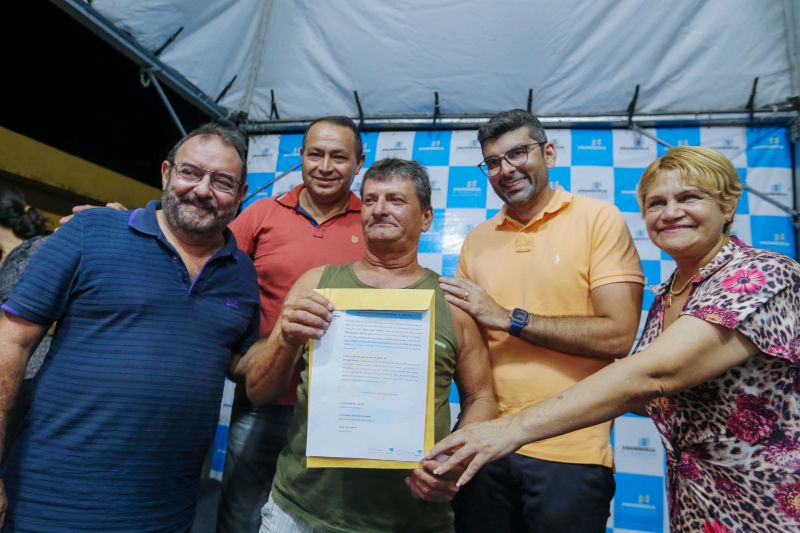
[0,124,259,532]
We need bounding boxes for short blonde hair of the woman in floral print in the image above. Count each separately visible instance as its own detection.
[636,146,742,233]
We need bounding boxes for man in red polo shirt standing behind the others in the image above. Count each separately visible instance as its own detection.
[217,117,364,533]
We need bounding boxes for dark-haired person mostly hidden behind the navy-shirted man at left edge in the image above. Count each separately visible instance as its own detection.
[0,185,52,464]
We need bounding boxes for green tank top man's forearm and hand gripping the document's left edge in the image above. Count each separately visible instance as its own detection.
[247,267,333,405]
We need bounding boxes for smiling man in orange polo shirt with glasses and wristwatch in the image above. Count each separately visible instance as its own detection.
[441,109,644,533]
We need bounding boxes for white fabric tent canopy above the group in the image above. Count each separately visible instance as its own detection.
[59,0,800,130]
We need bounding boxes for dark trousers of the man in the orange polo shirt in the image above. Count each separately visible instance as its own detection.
[453,454,616,533]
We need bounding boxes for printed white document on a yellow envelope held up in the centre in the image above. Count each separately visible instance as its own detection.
[307,289,435,468]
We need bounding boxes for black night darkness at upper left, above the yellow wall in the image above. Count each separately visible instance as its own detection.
[0,0,208,189]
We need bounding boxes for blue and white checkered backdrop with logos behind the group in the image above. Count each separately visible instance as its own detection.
[212,127,796,532]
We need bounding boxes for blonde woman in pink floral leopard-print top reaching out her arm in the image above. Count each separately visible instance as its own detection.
[431,147,800,532]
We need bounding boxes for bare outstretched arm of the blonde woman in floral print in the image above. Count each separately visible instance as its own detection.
[426,316,758,486]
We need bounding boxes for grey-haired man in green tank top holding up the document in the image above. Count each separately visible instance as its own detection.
[245,159,497,533]
